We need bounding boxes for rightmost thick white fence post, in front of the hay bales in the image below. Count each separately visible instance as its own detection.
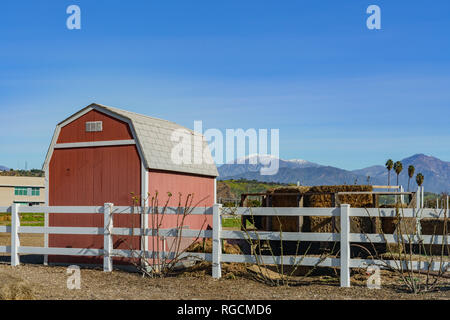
[340,204,350,288]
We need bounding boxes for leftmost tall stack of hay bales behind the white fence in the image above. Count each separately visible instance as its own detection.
[267,186,310,232]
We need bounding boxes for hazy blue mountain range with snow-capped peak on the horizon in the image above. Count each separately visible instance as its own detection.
[218,154,450,193]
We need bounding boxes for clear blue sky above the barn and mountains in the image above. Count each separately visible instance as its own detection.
[0,0,450,169]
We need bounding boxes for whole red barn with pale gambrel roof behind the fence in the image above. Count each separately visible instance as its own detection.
[44,104,218,264]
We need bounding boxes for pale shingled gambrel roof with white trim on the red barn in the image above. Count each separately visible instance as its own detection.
[44,103,219,177]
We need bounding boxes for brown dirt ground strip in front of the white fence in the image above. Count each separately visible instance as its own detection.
[0,263,450,300]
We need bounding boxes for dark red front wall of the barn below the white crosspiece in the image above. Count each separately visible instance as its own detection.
[49,146,141,263]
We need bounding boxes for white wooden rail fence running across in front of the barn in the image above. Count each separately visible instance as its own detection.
[0,197,449,287]
